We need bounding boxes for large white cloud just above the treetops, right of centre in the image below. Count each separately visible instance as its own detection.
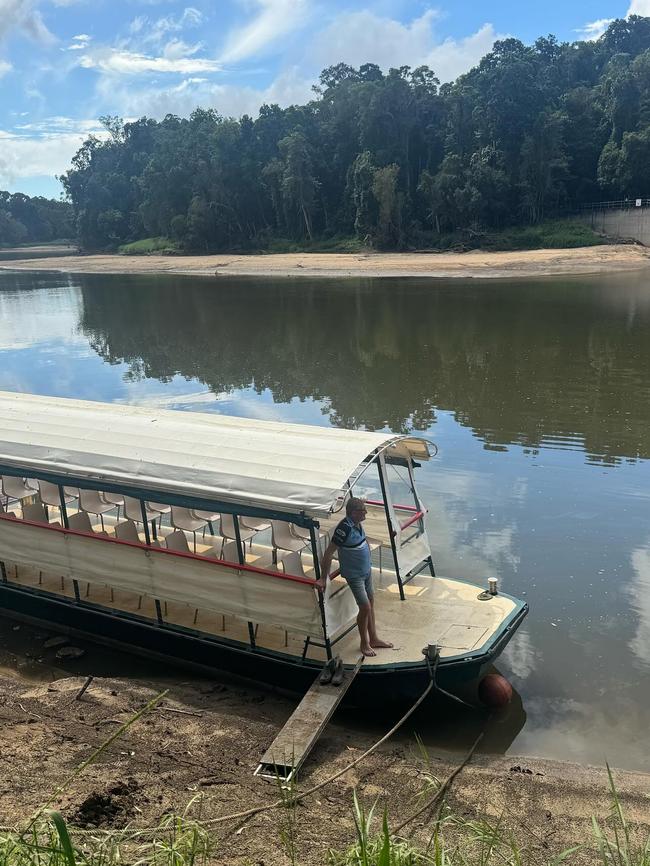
[311,9,503,81]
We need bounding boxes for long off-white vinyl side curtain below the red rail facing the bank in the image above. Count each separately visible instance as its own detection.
[0,518,338,640]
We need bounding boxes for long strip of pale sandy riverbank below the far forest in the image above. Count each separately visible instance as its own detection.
[3,245,650,278]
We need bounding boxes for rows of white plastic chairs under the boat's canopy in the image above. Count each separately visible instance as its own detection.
[1,475,329,574]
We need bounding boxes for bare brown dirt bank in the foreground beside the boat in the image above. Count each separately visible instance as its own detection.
[0,625,650,866]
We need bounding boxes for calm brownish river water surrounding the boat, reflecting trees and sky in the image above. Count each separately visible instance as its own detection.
[0,271,650,770]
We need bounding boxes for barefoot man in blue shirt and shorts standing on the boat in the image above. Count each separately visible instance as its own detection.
[317,497,392,656]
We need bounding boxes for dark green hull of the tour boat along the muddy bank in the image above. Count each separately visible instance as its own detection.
[0,583,528,707]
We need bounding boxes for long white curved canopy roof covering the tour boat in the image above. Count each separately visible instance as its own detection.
[0,391,429,516]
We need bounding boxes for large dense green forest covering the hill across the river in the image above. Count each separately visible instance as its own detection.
[62,15,650,251]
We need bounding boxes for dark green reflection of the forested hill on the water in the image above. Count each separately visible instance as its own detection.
[73,277,650,462]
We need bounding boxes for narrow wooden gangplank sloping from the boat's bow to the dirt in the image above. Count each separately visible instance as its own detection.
[254,656,364,782]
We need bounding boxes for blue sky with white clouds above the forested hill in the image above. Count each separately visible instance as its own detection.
[0,0,650,198]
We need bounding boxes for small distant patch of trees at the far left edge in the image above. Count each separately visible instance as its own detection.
[0,190,75,244]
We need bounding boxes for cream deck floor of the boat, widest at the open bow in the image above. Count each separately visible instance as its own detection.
[1,502,515,665]
